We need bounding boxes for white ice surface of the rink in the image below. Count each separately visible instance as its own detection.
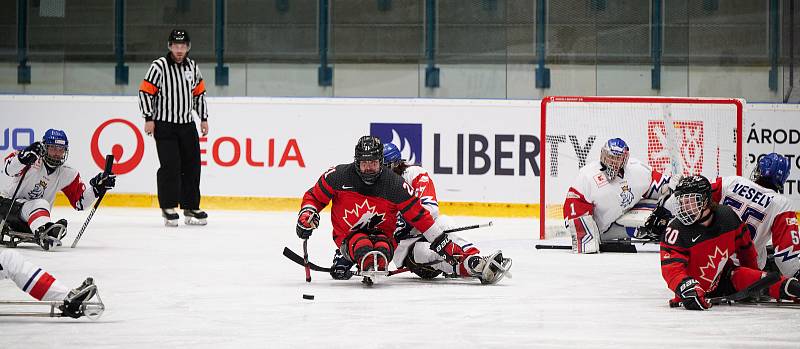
[0,207,800,349]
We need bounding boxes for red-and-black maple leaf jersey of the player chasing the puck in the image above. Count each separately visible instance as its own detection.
[302,163,434,246]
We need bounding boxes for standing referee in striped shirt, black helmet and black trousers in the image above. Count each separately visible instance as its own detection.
[139,29,208,227]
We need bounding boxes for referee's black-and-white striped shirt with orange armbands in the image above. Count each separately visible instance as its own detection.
[139,53,208,124]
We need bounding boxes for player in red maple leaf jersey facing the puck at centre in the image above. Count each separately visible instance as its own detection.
[296,136,468,278]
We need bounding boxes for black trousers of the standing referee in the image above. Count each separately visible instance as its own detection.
[153,121,200,210]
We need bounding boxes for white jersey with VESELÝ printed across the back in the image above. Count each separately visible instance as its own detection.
[708,176,800,276]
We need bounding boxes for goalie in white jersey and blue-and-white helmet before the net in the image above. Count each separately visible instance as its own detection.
[564,138,669,253]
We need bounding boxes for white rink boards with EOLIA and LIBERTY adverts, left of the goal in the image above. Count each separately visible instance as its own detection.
[0,96,539,203]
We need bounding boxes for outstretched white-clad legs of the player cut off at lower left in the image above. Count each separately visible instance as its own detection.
[0,249,104,319]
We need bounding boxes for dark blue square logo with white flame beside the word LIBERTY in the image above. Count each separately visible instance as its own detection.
[369,122,422,164]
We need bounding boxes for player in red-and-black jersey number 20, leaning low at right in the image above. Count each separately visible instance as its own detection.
[661,175,800,310]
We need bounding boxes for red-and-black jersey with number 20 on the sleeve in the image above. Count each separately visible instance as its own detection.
[661,205,758,292]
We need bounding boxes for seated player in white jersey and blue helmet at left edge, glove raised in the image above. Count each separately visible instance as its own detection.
[0,129,116,250]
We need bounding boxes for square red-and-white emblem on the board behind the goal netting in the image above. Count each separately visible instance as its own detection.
[647,120,705,176]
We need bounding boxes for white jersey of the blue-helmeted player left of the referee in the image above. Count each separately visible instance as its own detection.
[2,153,96,210]
